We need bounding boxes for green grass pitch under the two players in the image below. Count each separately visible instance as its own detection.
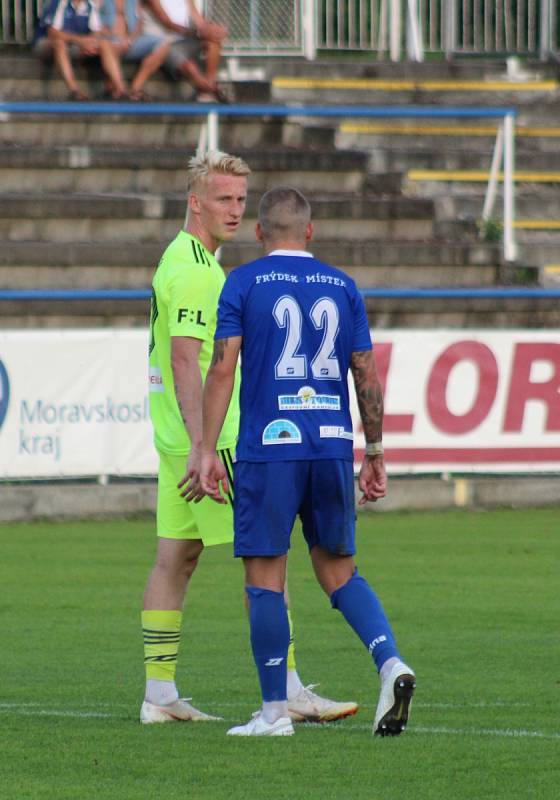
[0,509,560,800]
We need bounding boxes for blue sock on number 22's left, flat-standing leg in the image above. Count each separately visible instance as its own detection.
[245,586,290,702]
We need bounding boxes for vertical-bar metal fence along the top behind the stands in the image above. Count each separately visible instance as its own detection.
[0,0,560,61]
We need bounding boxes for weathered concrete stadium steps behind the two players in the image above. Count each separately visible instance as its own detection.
[0,48,560,327]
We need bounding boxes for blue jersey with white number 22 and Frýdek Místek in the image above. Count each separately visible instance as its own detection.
[215,251,371,461]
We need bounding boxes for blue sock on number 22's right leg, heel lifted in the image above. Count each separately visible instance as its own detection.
[331,570,400,672]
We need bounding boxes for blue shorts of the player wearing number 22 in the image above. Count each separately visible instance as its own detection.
[233,459,356,556]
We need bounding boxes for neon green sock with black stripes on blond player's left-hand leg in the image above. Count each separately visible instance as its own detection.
[142,611,183,681]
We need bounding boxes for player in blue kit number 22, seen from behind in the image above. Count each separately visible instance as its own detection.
[201,187,416,736]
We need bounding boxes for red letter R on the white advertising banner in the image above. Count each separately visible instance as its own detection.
[504,342,560,432]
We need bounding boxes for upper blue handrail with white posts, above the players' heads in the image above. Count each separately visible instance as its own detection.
[0,96,516,261]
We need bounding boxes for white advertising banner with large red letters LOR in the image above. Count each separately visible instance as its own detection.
[353,330,560,473]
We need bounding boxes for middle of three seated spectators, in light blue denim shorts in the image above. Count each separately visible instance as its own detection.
[101,0,171,102]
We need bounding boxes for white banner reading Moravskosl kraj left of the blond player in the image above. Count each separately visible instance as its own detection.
[0,329,157,478]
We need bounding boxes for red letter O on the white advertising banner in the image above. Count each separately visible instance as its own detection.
[426,340,498,434]
